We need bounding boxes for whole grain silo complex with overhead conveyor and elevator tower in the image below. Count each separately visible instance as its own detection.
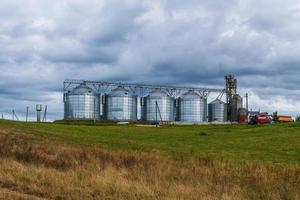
[63,76,242,123]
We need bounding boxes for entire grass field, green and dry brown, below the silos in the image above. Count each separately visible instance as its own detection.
[0,121,300,199]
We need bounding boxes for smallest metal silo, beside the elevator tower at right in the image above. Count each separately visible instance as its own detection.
[208,99,227,122]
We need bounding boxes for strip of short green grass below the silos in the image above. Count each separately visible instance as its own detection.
[0,121,300,164]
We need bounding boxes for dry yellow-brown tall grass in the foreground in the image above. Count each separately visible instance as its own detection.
[0,127,300,200]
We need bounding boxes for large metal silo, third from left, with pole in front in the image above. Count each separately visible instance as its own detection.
[143,89,175,122]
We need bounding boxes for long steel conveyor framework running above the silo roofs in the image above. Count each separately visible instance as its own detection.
[63,79,226,98]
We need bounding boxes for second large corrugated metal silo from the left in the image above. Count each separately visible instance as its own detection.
[105,86,137,121]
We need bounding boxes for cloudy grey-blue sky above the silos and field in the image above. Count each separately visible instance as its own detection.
[0,0,300,119]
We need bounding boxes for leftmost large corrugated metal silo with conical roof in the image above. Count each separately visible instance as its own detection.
[64,83,100,119]
